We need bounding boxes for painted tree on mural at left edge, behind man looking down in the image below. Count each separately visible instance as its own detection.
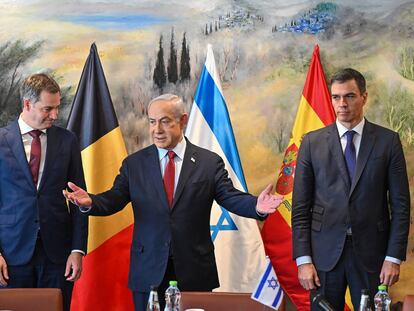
[0,40,43,126]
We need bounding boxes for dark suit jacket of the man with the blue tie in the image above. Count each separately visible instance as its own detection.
[292,121,410,273]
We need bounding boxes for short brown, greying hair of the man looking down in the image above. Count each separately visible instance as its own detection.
[20,73,60,104]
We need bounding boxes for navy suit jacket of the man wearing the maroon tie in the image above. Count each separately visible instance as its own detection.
[0,121,88,265]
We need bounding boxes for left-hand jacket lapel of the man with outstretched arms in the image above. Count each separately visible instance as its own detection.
[144,145,170,210]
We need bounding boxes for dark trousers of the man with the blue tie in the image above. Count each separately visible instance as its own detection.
[311,236,380,311]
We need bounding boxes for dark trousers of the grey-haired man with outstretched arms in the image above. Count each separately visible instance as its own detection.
[132,257,180,311]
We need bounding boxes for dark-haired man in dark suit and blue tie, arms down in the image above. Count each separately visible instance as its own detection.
[292,68,410,310]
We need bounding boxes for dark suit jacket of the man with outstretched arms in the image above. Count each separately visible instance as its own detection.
[90,141,258,292]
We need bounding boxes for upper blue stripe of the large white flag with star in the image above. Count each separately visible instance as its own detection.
[194,66,247,191]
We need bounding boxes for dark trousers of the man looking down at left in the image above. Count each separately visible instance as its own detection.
[7,237,73,311]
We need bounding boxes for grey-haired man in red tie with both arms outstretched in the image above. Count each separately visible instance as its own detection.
[64,94,281,311]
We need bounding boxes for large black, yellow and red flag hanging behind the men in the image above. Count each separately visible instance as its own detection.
[67,43,133,311]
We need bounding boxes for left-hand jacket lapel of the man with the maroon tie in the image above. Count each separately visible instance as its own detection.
[5,121,35,187]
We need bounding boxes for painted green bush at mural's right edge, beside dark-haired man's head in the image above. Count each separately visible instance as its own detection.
[381,86,414,147]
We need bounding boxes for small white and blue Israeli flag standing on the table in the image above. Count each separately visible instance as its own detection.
[252,258,283,310]
